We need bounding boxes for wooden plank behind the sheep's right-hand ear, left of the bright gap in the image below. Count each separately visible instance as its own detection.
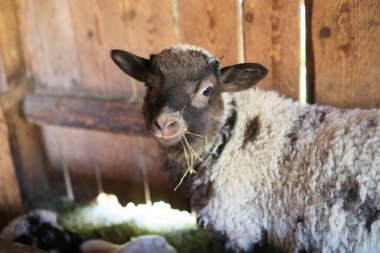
[243,0,301,99]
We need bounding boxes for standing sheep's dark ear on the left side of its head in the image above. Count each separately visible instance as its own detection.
[111,50,150,82]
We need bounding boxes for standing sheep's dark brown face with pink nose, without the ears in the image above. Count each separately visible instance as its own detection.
[144,50,223,146]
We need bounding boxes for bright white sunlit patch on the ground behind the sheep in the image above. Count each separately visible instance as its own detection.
[86,193,197,232]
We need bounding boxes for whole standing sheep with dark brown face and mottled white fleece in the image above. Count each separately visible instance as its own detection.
[111,45,380,252]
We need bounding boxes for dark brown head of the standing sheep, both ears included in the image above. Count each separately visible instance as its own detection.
[111,45,268,147]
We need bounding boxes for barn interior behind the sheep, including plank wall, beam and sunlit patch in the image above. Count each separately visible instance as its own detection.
[0,0,380,252]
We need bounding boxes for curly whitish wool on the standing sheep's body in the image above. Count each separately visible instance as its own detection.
[197,89,380,252]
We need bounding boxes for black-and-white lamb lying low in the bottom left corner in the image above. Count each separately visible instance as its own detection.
[0,210,82,253]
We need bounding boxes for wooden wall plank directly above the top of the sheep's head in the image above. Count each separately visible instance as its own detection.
[178,0,239,66]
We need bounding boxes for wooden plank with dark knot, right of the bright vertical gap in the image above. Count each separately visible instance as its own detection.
[310,0,380,108]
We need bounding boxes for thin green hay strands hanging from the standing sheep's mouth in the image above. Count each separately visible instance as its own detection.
[174,131,208,191]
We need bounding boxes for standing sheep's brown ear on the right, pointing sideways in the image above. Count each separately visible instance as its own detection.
[221,63,268,92]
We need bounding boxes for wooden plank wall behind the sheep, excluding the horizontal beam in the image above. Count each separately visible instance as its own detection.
[0,0,380,225]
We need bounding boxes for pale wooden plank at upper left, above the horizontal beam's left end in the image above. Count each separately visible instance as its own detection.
[18,0,80,91]
